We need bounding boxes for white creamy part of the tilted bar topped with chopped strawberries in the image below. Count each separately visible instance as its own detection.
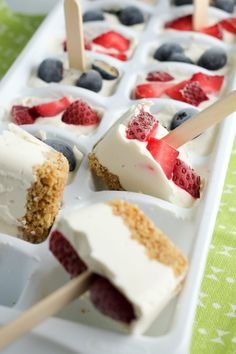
[93,103,204,207]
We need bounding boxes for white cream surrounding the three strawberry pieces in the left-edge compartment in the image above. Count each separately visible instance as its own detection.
[2,97,102,136]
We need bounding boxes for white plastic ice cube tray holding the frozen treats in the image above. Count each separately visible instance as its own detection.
[0,0,236,354]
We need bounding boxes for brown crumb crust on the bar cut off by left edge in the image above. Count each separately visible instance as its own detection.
[19,151,69,243]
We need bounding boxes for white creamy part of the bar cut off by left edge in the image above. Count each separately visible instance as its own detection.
[0,124,50,234]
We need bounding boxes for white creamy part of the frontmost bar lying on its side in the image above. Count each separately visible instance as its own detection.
[57,203,185,333]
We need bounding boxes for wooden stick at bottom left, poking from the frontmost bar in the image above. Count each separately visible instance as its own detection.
[0,271,94,350]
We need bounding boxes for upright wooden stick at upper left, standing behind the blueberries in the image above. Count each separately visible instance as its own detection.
[64,0,85,71]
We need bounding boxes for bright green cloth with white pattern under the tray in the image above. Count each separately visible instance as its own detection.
[0,0,236,354]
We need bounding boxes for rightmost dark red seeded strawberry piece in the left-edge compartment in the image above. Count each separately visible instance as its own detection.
[62,100,100,126]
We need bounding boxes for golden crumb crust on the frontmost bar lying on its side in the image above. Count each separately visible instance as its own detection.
[108,200,188,277]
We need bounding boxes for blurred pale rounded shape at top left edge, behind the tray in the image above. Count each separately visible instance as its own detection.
[6,0,58,14]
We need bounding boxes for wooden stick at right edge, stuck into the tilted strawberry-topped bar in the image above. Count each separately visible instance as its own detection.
[162,91,236,149]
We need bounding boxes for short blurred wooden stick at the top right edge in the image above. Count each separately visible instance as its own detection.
[193,0,209,31]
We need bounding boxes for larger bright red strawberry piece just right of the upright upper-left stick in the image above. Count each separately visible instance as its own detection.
[93,31,130,52]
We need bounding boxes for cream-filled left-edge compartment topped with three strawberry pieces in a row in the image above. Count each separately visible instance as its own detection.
[2,96,103,136]
